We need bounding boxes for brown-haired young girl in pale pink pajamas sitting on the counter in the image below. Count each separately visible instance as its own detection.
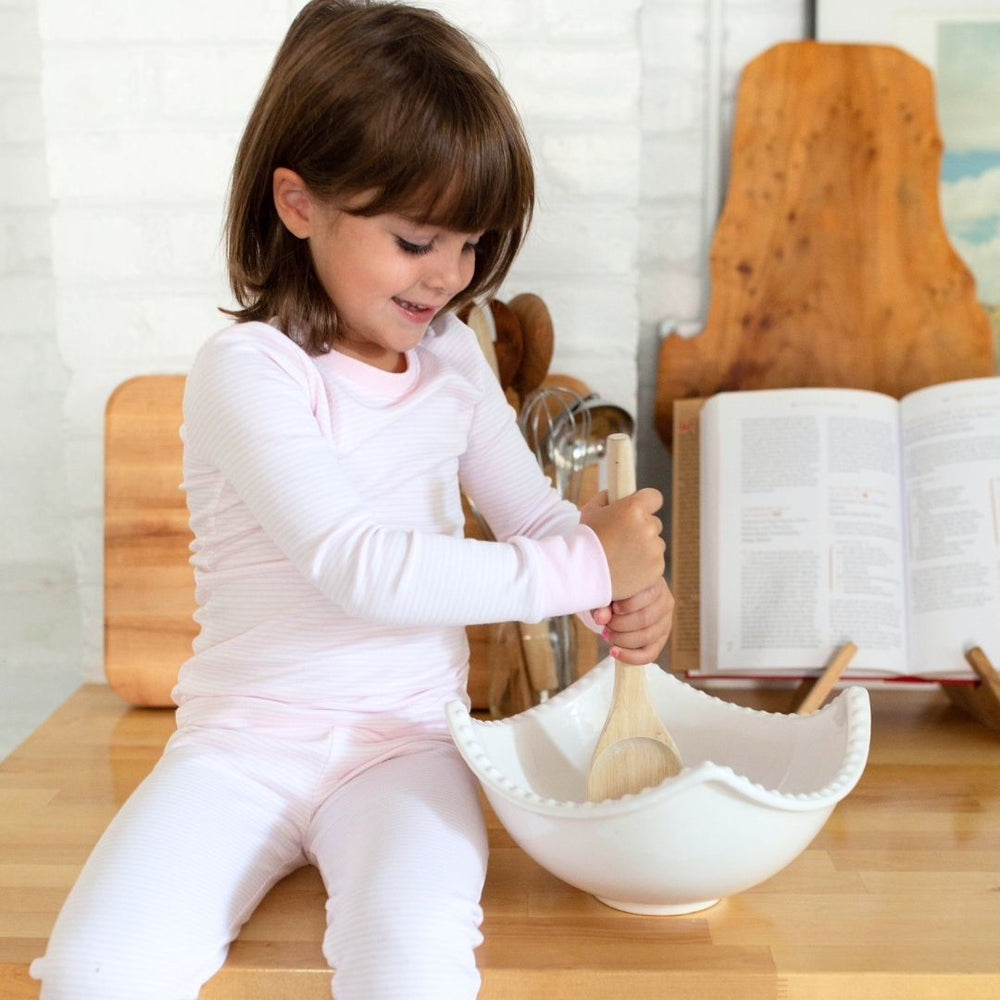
[32,0,671,1000]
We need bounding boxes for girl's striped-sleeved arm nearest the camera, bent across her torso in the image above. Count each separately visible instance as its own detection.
[185,327,611,625]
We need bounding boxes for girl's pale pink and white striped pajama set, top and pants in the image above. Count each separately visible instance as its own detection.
[32,314,611,1000]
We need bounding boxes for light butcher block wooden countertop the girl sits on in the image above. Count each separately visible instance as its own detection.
[0,685,1000,1000]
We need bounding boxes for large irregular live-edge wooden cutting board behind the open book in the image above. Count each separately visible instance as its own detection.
[656,42,993,447]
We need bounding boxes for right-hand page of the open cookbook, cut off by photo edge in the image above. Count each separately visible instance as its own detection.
[900,378,1000,677]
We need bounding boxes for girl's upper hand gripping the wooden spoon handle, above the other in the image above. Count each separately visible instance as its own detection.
[580,488,666,600]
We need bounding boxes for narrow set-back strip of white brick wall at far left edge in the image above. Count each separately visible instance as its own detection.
[0,0,81,755]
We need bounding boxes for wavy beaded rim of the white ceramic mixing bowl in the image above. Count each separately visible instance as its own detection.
[445,659,871,820]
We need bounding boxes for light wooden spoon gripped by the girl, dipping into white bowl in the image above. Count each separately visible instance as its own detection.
[587,434,684,802]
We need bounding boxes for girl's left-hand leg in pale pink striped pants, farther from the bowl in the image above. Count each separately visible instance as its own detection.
[32,746,304,1000]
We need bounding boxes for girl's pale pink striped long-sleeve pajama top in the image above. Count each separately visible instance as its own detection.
[174,314,611,725]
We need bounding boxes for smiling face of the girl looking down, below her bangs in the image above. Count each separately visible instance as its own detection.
[309,199,480,372]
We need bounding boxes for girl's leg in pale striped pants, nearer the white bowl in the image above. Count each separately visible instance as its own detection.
[307,741,487,1000]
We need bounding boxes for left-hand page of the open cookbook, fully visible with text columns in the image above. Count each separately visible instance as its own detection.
[701,389,906,676]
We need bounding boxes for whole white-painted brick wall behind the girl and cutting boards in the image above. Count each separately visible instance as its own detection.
[0,0,805,736]
